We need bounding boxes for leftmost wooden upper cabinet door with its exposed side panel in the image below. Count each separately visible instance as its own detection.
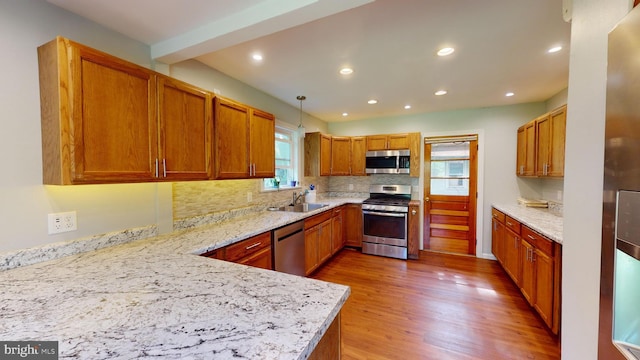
[38,37,158,185]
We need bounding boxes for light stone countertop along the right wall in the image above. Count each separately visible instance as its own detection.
[493,204,563,244]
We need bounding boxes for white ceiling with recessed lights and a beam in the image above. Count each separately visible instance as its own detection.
[47,0,570,122]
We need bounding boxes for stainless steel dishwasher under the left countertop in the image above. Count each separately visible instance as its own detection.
[273,220,305,276]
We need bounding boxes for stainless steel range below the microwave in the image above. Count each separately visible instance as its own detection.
[362,185,411,259]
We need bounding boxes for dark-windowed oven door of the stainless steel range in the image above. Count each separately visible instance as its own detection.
[362,210,407,246]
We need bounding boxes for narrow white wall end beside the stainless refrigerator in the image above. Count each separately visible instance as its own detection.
[562,0,631,360]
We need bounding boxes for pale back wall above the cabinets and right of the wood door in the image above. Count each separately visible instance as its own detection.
[329,102,546,257]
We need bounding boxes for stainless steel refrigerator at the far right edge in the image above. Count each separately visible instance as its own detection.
[598,7,640,360]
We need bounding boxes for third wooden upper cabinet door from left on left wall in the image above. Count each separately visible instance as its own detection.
[213,97,248,179]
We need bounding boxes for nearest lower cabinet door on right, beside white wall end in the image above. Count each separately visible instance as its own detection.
[533,249,554,327]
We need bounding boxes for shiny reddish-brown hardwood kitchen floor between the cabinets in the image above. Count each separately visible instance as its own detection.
[311,248,560,360]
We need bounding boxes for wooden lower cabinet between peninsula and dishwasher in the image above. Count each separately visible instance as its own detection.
[202,231,273,270]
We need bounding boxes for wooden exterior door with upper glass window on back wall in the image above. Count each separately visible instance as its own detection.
[423,136,478,255]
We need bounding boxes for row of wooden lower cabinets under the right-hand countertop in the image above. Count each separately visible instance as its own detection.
[491,209,562,334]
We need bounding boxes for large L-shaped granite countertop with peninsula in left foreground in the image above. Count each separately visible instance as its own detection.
[0,199,362,359]
